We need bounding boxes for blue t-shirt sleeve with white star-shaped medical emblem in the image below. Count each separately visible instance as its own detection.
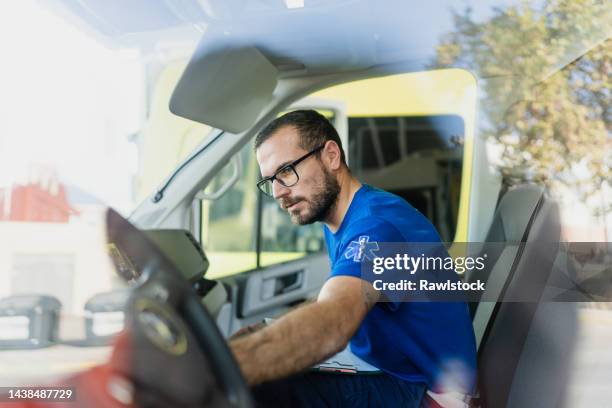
[330,218,404,278]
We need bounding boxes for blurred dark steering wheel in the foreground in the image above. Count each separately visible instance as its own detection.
[106,210,253,407]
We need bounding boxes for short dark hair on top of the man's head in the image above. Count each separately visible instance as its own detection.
[255,109,346,165]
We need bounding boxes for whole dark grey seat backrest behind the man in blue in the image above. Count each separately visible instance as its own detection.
[474,188,561,407]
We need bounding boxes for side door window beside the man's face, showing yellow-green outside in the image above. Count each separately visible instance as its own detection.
[201,135,323,279]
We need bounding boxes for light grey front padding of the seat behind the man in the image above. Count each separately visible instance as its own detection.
[466,185,545,345]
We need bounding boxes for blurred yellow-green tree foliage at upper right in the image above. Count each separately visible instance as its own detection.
[436,0,612,214]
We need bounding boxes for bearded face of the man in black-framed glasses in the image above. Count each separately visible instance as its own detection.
[257,126,340,225]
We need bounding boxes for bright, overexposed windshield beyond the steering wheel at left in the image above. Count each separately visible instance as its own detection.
[0,0,212,387]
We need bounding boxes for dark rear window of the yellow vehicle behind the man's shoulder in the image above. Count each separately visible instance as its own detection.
[348,115,465,241]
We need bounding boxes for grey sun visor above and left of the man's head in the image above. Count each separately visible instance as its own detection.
[170,44,278,133]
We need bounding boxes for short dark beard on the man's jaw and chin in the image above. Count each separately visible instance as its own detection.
[281,168,340,225]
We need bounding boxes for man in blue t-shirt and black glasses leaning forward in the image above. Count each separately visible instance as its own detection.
[230,110,475,407]
